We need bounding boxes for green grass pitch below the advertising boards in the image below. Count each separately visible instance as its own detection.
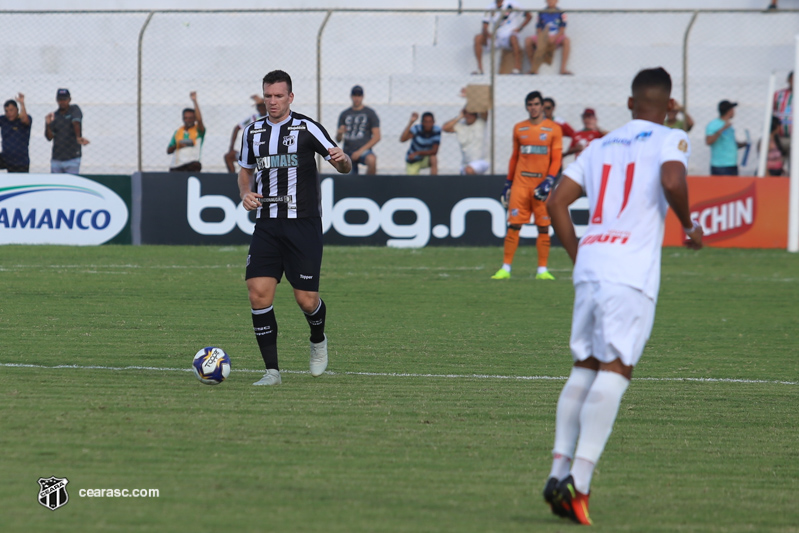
[0,246,799,533]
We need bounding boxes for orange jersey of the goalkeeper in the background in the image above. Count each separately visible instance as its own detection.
[508,119,563,183]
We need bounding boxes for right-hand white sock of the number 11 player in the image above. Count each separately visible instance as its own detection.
[571,371,630,494]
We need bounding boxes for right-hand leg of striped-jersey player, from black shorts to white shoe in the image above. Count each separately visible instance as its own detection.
[285,218,328,377]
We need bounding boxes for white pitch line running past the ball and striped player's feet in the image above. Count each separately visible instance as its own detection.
[0,363,799,385]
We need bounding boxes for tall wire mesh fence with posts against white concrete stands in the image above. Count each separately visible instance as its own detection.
[0,10,799,174]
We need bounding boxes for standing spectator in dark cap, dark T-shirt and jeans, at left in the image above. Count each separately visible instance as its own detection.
[44,89,89,174]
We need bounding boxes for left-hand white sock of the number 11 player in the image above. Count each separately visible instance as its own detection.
[549,366,597,479]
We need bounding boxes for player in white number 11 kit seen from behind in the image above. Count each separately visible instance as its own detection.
[544,68,702,525]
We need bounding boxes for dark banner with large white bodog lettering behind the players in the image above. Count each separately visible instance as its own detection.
[132,174,588,248]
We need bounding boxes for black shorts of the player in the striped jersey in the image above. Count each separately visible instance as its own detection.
[246,217,322,292]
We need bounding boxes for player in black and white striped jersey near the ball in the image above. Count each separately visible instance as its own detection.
[238,70,352,385]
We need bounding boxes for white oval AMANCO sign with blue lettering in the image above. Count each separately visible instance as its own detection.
[0,174,129,245]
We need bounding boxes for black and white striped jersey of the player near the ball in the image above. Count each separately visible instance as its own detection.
[239,111,336,218]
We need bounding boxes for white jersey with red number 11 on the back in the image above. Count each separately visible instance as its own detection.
[563,120,690,300]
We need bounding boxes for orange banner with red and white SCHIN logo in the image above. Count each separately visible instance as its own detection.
[663,176,790,248]
